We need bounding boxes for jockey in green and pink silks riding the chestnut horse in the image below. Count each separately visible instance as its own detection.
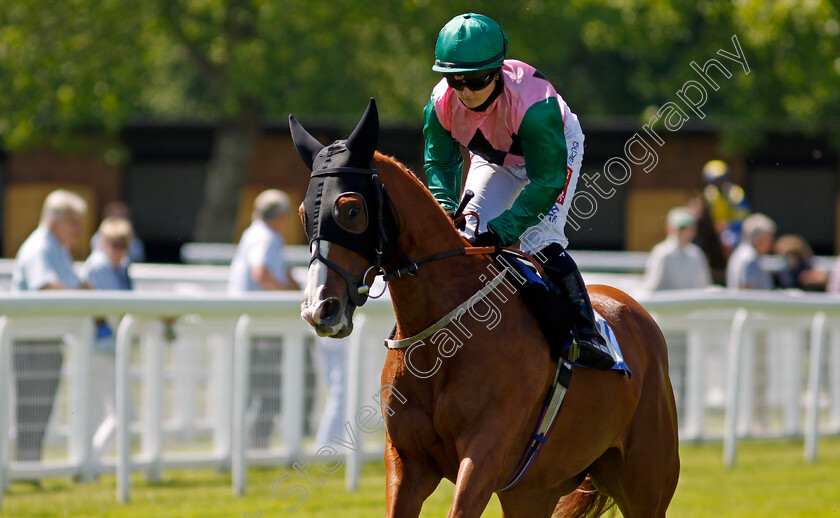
[423,13,613,369]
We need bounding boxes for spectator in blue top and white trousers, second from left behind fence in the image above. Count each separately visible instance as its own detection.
[82,216,134,472]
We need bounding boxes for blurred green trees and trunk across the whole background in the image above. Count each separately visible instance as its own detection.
[0,0,840,241]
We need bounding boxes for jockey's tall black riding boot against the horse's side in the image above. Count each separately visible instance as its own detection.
[534,243,615,369]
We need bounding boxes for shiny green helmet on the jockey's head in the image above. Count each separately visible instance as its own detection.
[432,13,507,73]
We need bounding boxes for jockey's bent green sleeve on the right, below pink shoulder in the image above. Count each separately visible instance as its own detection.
[487,98,568,245]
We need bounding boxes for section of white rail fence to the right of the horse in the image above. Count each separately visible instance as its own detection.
[640,290,840,466]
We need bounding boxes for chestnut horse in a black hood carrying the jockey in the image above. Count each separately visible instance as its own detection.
[290,99,679,518]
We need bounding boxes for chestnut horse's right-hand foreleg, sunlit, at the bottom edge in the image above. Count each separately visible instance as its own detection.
[447,442,503,518]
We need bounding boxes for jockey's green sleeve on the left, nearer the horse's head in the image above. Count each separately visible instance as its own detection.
[423,99,464,210]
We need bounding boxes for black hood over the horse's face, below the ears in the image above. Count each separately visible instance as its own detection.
[304,167,399,306]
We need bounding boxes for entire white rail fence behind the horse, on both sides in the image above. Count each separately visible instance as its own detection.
[0,291,840,510]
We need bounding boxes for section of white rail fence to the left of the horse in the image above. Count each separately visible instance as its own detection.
[0,292,394,510]
